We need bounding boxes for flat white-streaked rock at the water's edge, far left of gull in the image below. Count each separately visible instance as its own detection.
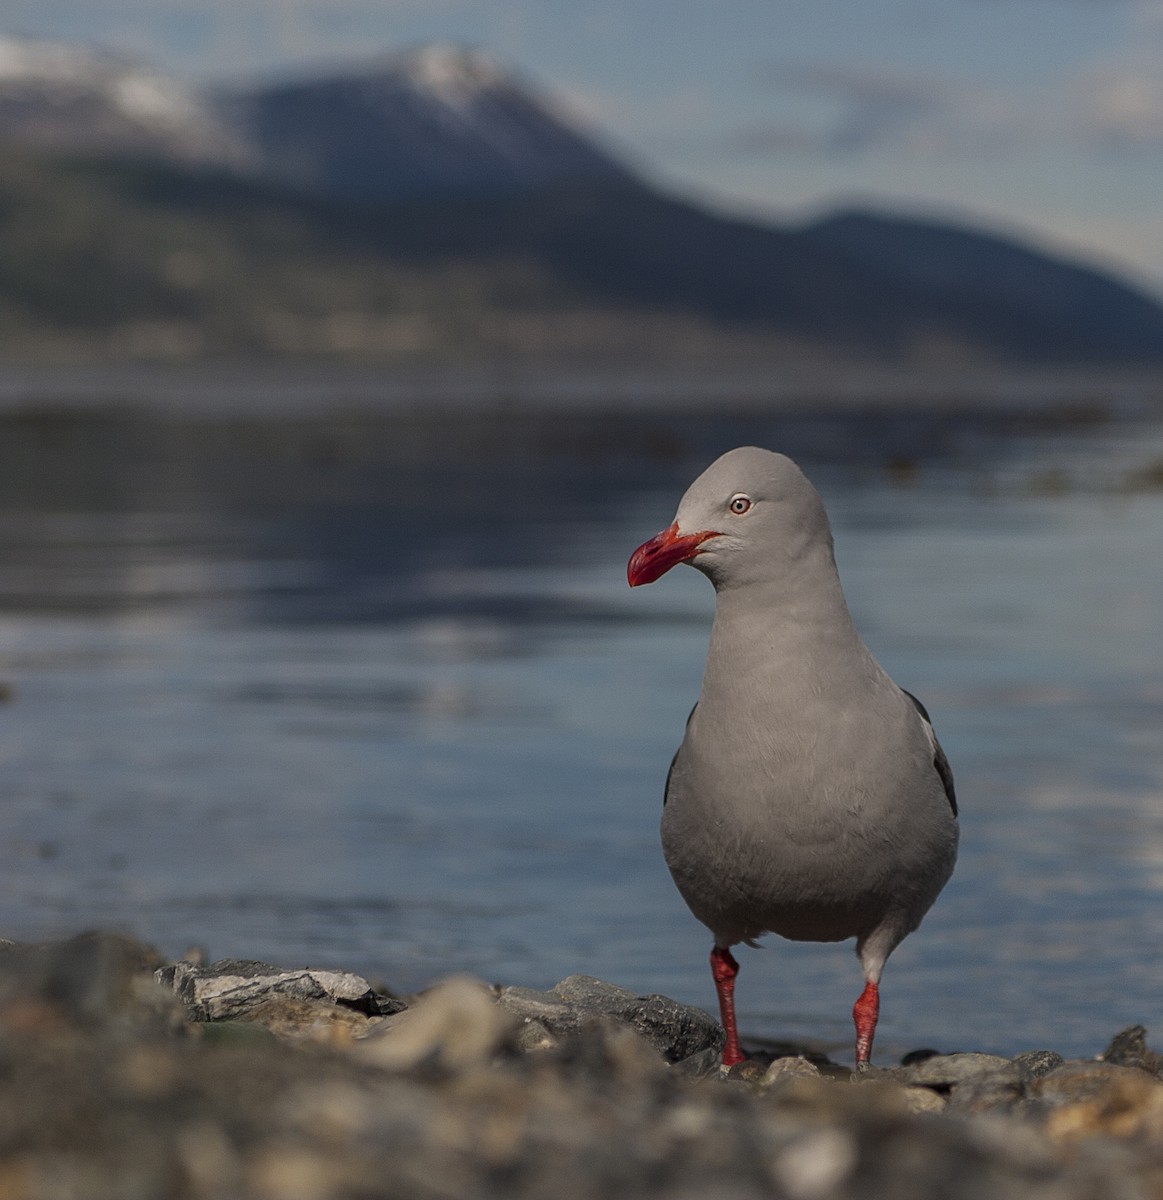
[157,959,403,1032]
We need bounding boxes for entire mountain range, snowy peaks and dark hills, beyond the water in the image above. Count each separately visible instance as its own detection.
[0,38,1163,364]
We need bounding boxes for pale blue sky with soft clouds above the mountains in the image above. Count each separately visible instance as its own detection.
[0,0,1163,295]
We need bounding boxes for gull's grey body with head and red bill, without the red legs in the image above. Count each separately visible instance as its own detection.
[630,446,958,1061]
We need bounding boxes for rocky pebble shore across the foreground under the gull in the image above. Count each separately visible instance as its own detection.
[0,934,1163,1200]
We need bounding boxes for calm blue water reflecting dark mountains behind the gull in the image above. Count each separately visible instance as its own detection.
[0,384,1163,1057]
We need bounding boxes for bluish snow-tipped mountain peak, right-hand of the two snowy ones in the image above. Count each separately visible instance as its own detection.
[218,44,634,200]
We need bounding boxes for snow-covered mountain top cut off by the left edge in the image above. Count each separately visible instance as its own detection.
[0,36,250,166]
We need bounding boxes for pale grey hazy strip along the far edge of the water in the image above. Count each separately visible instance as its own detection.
[0,361,1163,419]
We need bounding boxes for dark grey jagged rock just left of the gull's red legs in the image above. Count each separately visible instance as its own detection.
[499,976,726,1063]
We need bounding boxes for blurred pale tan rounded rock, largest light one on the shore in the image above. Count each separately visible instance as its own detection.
[360,977,518,1073]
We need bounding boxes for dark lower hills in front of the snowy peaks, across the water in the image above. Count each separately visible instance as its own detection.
[0,154,1163,362]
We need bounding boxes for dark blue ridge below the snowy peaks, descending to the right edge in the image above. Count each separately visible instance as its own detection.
[362,188,1163,362]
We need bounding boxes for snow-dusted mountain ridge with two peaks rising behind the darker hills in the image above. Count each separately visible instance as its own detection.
[0,36,634,199]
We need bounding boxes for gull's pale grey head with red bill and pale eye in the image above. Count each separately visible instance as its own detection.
[627,446,832,589]
